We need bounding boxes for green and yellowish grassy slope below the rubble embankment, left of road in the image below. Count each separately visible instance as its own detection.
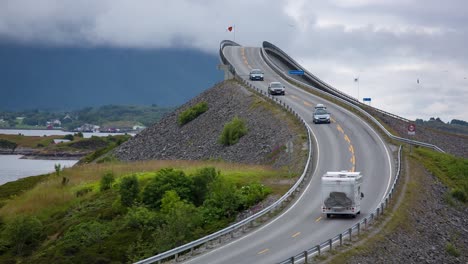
[0,161,288,263]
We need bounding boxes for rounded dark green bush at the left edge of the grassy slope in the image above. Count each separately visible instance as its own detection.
[2,216,44,255]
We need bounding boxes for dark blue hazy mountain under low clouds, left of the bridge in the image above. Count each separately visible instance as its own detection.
[0,42,223,111]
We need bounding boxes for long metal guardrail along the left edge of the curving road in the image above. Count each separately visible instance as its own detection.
[136,40,312,264]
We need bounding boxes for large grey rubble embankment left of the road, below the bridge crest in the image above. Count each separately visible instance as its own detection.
[113,81,306,167]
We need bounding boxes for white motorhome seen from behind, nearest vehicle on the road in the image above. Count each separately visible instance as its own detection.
[322,171,364,218]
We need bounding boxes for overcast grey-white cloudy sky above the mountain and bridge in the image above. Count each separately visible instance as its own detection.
[0,0,468,122]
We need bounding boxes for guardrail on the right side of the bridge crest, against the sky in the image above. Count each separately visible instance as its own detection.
[261,41,445,153]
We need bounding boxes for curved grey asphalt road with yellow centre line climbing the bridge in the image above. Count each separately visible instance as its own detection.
[187,47,393,263]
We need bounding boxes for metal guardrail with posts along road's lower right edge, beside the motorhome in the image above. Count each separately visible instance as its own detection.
[280,146,402,264]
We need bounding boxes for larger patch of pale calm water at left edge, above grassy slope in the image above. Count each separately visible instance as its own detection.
[0,155,78,185]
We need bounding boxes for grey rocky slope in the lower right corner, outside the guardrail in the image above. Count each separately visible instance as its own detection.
[346,162,468,264]
